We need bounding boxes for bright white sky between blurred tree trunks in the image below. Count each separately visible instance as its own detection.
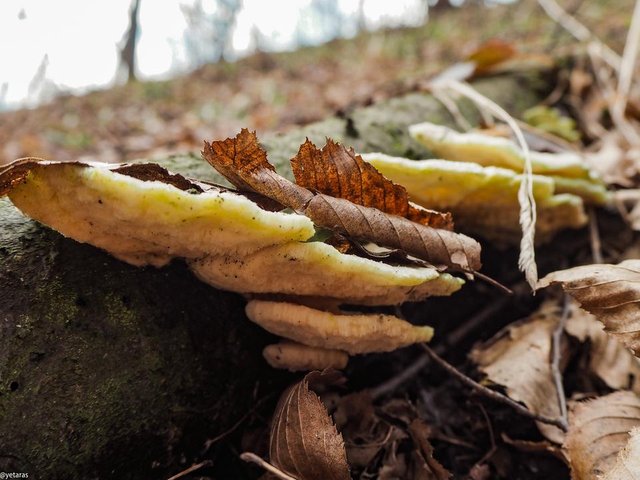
[0,0,423,106]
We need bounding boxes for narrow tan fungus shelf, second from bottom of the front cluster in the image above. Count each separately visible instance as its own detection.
[246,300,433,355]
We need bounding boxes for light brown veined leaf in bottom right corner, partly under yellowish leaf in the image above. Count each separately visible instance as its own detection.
[564,392,640,480]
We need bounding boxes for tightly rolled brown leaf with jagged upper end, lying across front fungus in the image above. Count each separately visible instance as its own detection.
[202,129,481,270]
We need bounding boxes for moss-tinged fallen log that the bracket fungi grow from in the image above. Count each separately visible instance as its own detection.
[0,76,544,479]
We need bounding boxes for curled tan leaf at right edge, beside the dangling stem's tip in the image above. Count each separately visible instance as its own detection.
[538,260,640,356]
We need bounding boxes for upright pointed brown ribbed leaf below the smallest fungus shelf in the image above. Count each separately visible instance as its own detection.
[269,372,351,480]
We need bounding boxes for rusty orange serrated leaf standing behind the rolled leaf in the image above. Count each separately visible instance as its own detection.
[291,139,453,230]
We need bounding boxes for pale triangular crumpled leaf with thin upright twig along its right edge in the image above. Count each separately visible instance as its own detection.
[470,307,562,443]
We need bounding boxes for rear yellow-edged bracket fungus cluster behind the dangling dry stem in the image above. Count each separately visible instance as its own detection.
[363,123,609,243]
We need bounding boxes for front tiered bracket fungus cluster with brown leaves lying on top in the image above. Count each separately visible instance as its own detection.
[0,130,480,369]
